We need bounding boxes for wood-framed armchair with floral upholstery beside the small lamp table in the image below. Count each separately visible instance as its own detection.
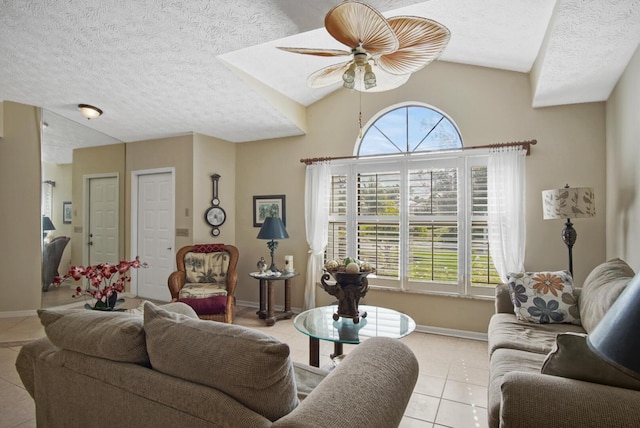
[168,244,238,324]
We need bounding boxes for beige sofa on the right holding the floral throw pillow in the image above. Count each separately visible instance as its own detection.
[488,259,640,428]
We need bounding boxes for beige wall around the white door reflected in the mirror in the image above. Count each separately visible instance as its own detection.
[71,143,127,265]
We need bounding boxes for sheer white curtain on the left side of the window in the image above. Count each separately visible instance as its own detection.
[304,162,331,309]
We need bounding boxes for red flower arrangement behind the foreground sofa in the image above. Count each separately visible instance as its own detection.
[54,257,147,309]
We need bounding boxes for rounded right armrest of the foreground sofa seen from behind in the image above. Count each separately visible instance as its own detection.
[273,337,418,428]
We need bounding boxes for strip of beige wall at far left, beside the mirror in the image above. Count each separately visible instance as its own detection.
[0,101,42,313]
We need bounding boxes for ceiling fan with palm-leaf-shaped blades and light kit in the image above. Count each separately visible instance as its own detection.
[278,1,451,92]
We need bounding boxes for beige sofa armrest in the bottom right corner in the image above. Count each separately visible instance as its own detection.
[500,372,640,428]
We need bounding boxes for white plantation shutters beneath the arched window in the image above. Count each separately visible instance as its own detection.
[325,153,500,295]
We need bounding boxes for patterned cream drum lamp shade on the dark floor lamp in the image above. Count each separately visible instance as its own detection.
[542,186,596,220]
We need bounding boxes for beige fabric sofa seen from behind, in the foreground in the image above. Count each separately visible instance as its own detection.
[16,303,418,428]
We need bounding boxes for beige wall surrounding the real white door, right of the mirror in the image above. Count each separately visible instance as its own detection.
[125,134,193,258]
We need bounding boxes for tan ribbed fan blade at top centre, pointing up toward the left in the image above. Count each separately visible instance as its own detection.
[324,1,399,55]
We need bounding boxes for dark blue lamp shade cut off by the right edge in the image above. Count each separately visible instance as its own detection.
[587,274,640,379]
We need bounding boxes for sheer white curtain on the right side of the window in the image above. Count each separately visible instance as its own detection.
[487,146,527,282]
